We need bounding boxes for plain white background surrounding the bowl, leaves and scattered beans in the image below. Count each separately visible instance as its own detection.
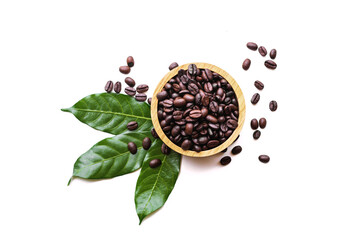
[0,0,360,240]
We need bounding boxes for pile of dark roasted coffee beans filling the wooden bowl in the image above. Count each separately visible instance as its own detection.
[157,63,239,152]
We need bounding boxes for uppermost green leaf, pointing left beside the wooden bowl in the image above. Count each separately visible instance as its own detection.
[61,93,152,135]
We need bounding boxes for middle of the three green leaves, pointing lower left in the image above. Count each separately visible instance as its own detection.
[73,131,154,179]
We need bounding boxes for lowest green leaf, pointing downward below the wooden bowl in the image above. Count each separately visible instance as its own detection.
[135,139,181,224]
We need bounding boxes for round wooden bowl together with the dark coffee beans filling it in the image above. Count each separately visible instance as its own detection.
[151,63,245,157]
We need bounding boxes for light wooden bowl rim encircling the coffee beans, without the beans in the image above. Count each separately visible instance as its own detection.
[151,63,246,157]
